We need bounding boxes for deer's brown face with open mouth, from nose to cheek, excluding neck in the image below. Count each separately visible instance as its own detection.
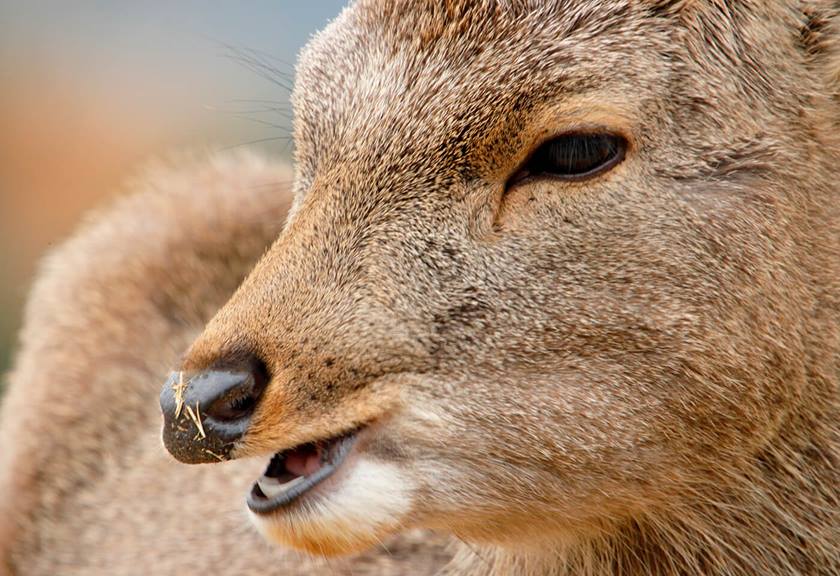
[163,1,822,554]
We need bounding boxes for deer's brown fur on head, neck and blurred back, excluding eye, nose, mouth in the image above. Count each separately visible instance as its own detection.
[0,0,840,575]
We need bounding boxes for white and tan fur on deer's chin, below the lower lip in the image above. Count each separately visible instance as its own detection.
[248,458,414,556]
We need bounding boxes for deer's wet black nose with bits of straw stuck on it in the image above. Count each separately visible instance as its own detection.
[160,369,268,464]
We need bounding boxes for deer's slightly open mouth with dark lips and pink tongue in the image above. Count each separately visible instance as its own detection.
[247,431,356,514]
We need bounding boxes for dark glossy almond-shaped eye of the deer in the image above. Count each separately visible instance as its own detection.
[508,133,627,187]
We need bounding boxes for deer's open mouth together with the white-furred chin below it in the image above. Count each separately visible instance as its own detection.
[247,430,414,556]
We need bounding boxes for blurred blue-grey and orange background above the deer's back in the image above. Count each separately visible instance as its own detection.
[0,0,346,386]
